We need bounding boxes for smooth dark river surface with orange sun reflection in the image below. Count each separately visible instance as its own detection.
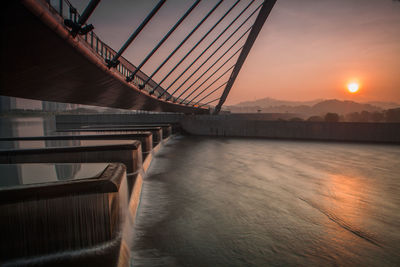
[133,137,400,266]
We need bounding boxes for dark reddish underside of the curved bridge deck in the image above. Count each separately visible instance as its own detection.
[0,1,208,113]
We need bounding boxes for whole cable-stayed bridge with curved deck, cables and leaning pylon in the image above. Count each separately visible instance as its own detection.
[0,0,276,114]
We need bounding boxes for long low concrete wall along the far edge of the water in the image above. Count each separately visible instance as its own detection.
[51,114,400,144]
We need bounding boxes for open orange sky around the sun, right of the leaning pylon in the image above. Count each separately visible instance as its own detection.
[226,0,400,104]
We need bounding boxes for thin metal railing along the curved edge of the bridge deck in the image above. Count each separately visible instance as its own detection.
[46,0,178,99]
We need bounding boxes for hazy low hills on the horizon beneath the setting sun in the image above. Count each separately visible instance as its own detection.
[227,98,390,116]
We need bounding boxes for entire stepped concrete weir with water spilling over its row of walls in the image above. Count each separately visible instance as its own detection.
[0,120,175,266]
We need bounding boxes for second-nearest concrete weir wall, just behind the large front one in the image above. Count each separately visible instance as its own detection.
[0,140,143,195]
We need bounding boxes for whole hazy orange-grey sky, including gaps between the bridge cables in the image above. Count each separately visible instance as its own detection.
[72,0,400,104]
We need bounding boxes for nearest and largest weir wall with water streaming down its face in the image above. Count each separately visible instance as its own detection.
[0,164,131,266]
